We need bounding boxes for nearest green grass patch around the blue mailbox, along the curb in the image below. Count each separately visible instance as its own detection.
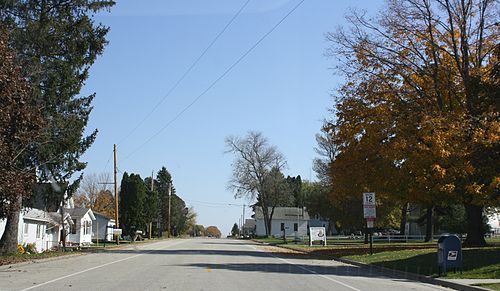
[343,247,500,279]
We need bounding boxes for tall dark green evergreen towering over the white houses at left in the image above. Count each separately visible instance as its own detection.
[0,0,114,250]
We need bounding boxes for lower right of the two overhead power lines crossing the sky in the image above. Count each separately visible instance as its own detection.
[125,0,305,159]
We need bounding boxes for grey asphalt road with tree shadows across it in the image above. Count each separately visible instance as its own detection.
[0,239,447,291]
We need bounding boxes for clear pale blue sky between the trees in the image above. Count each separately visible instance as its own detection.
[81,0,383,235]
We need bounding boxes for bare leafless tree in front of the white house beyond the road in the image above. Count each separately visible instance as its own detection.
[226,131,286,235]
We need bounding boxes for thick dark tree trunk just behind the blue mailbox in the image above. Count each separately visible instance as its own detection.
[464,204,486,247]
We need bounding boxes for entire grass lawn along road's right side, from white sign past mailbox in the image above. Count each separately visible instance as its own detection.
[257,238,500,280]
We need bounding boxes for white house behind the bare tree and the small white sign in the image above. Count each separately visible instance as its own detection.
[255,207,309,237]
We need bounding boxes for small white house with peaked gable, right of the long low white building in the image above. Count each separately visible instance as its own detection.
[64,208,96,246]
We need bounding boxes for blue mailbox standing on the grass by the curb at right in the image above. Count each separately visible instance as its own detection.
[438,235,462,275]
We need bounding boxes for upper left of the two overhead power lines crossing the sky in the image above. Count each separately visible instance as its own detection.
[118,0,250,144]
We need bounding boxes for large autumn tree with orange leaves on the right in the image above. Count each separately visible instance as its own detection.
[325,0,500,246]
